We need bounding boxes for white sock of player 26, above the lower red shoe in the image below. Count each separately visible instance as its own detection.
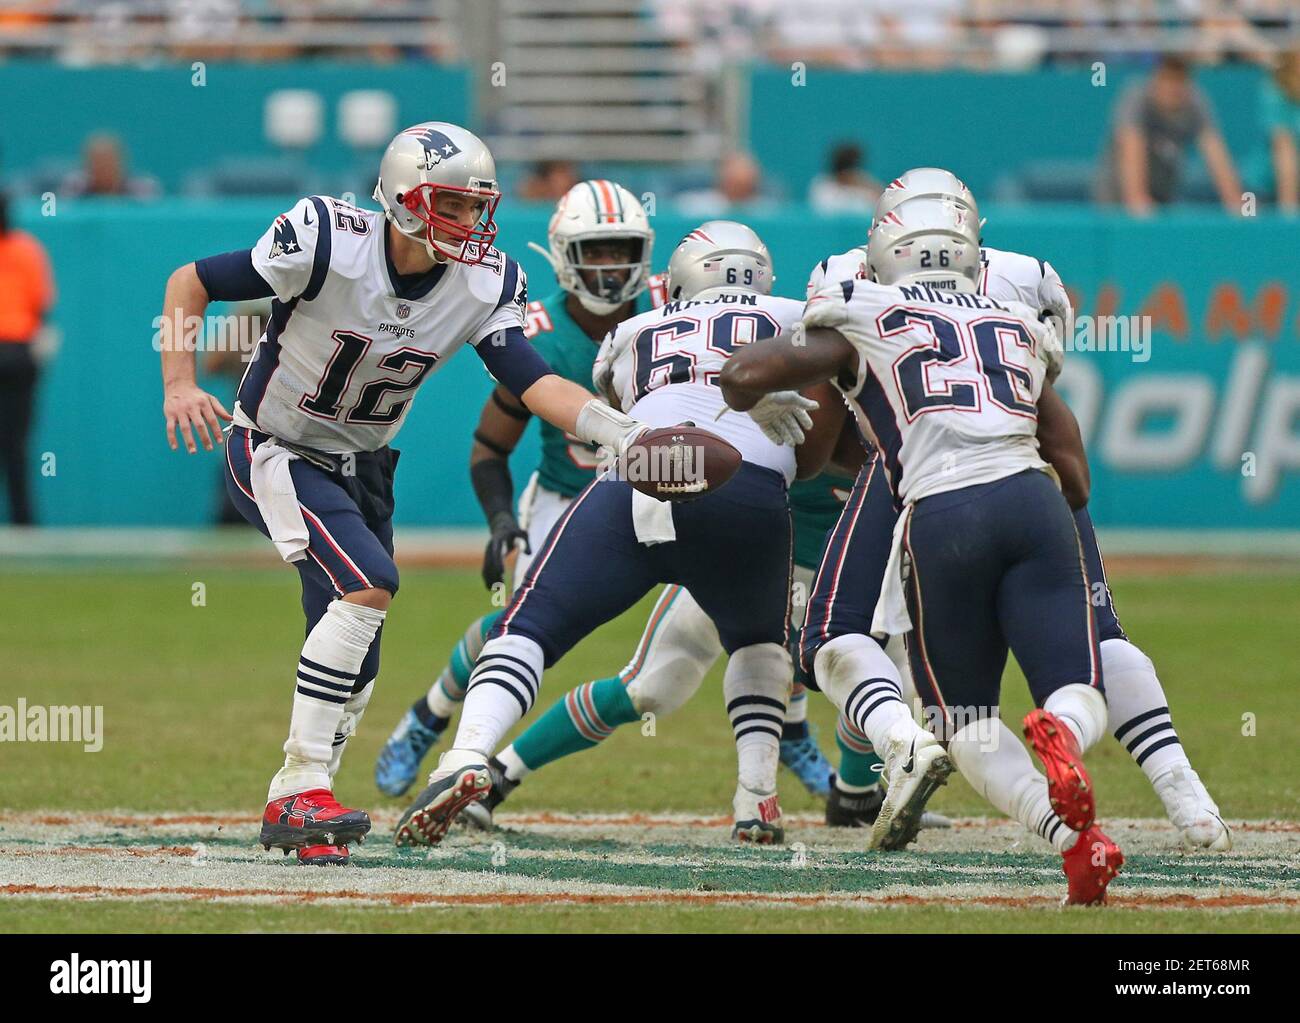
[948,719,1076,853]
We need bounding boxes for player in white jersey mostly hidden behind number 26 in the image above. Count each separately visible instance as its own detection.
[801,168,1231,851]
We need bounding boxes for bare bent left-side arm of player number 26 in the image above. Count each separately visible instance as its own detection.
[718,328,857,412]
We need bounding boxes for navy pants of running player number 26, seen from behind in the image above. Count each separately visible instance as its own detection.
[904,469,1101,721]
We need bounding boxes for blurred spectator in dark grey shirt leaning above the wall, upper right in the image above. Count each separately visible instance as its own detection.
[1097,56,1242,216]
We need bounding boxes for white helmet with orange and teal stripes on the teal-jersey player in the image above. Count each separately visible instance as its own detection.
[528,178,654,316]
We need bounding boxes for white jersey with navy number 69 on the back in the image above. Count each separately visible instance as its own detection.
[592,289,803,482]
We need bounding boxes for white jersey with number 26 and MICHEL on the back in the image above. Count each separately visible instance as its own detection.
[803,279,1060,504]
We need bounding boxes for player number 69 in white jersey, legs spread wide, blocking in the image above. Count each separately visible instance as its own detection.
[395,221,842,845]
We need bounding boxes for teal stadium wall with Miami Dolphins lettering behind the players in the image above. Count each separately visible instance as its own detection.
[10,200,1300,529]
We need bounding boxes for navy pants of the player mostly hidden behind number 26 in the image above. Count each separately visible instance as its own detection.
[800,455,1128,688]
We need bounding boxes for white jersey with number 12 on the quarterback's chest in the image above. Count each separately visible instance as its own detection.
[235,195,528,454]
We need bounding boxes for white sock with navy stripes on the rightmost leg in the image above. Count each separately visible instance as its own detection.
[1101,640,1191,783]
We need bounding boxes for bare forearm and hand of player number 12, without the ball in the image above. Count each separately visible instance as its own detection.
[159,263,230,455]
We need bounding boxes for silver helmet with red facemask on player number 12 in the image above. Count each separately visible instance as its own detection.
[374,121,501,264]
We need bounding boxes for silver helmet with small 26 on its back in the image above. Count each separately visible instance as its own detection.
[867,199,980,291]
